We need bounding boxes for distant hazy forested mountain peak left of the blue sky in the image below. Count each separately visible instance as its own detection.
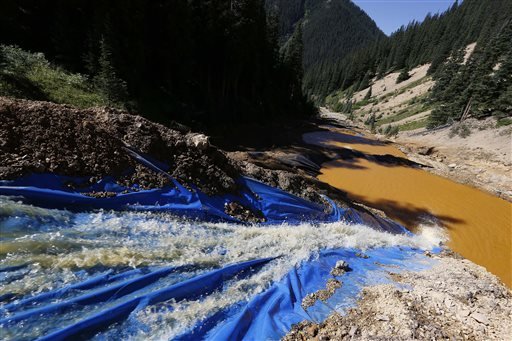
[266,0,385,96]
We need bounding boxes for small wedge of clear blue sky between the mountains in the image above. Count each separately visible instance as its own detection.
[352,0,454,35]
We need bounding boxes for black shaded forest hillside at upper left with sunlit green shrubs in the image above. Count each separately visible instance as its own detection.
[0,0,314,127]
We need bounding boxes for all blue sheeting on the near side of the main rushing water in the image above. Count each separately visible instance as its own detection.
[0,247,432,340]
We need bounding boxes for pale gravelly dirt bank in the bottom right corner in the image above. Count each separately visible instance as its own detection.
[284,252,512,341]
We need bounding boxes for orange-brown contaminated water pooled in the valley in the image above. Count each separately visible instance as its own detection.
[304,130,512,287]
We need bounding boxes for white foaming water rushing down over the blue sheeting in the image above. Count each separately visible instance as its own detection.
[0,198,446,339]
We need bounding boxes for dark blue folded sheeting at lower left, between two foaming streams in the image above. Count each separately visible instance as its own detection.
[0,258,272,340]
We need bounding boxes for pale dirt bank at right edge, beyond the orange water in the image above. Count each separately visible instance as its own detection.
[395,118,512,202]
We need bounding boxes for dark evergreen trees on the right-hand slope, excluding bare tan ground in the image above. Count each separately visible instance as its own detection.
[323,0,512,127]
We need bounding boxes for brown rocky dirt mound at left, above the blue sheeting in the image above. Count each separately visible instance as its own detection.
[0,97,239,194]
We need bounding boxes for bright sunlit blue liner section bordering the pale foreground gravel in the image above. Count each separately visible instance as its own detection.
[178,247,433,340]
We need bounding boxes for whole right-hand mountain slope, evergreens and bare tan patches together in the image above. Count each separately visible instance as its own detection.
[324,0,512,131]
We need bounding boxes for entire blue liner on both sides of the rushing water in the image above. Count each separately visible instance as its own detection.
[0,153,419,340]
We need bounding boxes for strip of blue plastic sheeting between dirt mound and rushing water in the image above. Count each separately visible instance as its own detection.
[0,174,342,224]
